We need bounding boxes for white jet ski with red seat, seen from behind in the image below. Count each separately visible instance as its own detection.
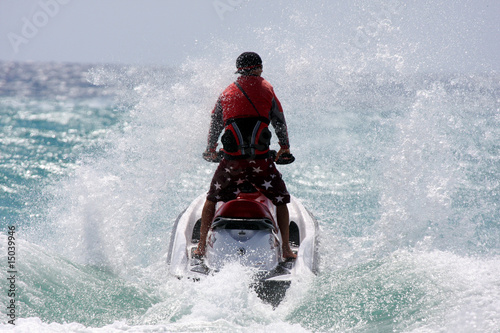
[167,152,319,307]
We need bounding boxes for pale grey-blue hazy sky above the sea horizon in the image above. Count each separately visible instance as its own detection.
[0,0,500,71]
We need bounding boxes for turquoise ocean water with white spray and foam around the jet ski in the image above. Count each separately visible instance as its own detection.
[0,6,500,332]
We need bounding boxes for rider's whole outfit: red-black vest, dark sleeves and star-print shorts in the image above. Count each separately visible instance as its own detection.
[207,75,290,206]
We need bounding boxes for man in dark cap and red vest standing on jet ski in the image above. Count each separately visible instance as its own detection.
[195,52,296,259]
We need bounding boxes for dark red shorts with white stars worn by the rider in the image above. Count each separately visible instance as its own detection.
[207,158,290,206]
